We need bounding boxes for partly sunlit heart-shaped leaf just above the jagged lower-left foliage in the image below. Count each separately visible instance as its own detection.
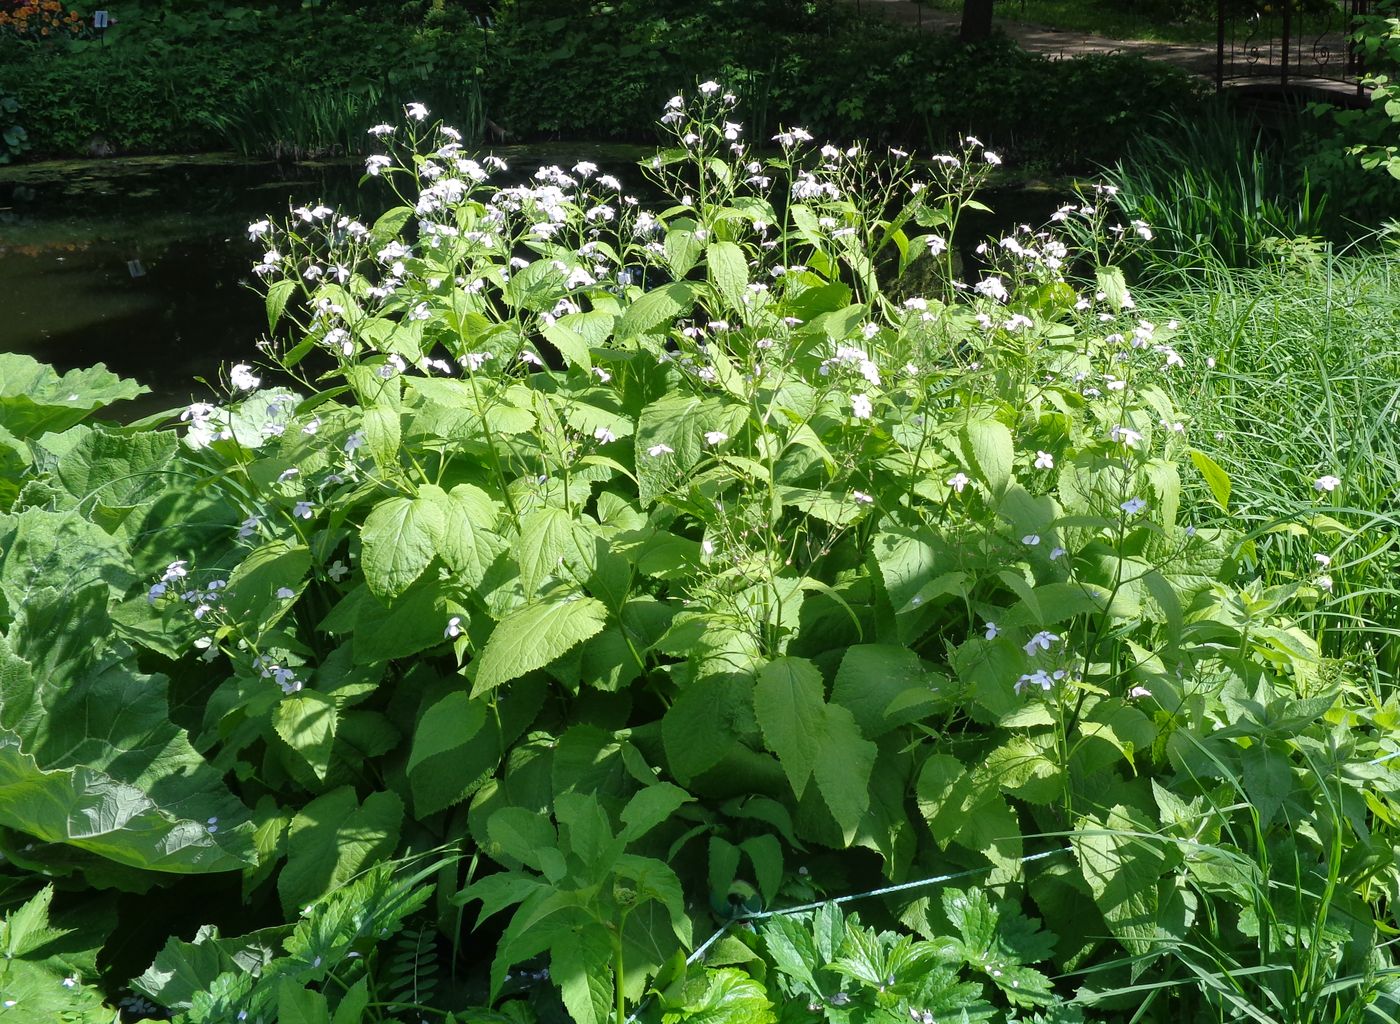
[277,786,403,916]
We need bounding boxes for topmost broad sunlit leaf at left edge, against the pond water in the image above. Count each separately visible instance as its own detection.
[0,352,148,437]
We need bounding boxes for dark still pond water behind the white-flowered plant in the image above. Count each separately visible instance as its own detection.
[0,143,1057,416]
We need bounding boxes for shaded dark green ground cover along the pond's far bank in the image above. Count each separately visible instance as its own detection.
[0,0,1200,168]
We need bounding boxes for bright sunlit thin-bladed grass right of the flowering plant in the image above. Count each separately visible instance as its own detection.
[1140,249,1400,693]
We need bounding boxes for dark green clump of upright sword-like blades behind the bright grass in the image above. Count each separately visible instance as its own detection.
[1105,102,1327,272]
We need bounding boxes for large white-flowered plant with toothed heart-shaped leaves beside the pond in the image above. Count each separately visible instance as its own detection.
[0,83,1376,1024]
